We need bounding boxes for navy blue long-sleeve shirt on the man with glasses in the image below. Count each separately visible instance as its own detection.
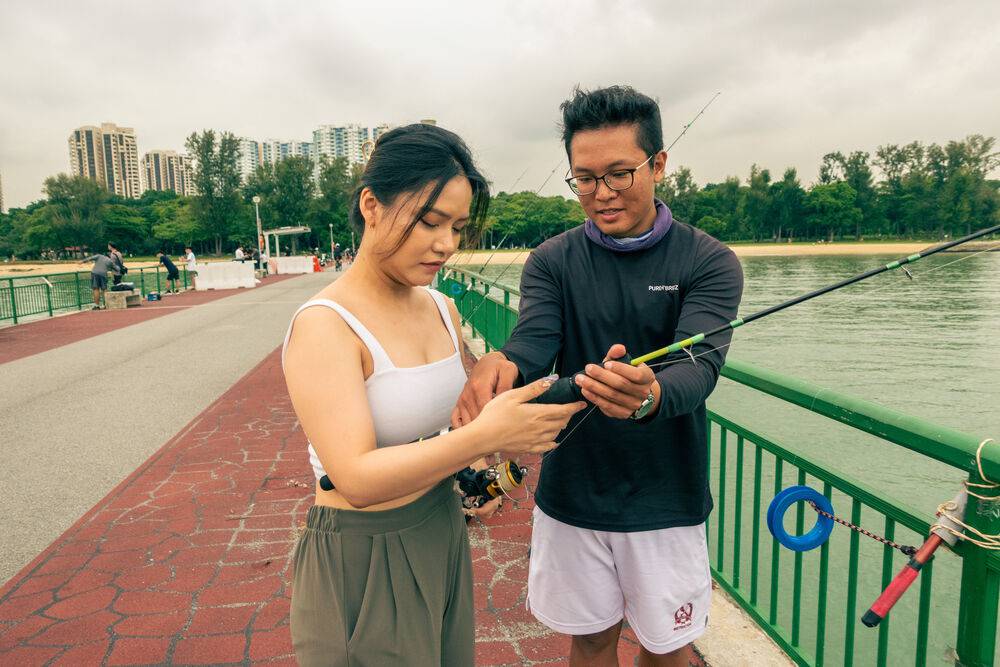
[501,221,743,532]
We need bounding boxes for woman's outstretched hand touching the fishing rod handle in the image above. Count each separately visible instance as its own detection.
[470,378,587,455]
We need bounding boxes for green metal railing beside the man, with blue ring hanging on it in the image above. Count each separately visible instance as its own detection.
[437,269,1000,665]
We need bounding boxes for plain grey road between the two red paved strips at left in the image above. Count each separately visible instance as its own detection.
[0,273,336,581]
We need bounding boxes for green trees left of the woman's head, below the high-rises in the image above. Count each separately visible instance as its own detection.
[0,130,359,259]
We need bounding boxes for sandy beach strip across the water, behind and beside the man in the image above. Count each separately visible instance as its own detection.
[449,242,933,265]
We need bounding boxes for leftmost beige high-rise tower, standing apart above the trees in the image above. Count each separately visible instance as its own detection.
[69,123,142,198]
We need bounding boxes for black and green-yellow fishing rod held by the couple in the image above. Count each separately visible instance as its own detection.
[534,225,1000,403]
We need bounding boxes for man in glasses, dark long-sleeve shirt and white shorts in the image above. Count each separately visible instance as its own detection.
[452,86,743,665]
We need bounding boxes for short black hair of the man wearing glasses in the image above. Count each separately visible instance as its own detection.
[559,86,663,160]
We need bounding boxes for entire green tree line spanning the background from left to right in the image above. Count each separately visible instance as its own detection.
[0,130,1000,258]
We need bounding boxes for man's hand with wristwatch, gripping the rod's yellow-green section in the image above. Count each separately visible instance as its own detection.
[576,343,660,419]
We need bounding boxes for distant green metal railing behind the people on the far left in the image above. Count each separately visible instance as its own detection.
[0,266,189,324]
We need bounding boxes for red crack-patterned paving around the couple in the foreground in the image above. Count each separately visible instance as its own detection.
[0,350,688,666]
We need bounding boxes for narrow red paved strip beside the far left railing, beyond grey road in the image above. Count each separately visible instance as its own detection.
[0,275,296,364]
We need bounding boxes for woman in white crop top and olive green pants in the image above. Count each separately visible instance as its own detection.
[284,125,584,666]
